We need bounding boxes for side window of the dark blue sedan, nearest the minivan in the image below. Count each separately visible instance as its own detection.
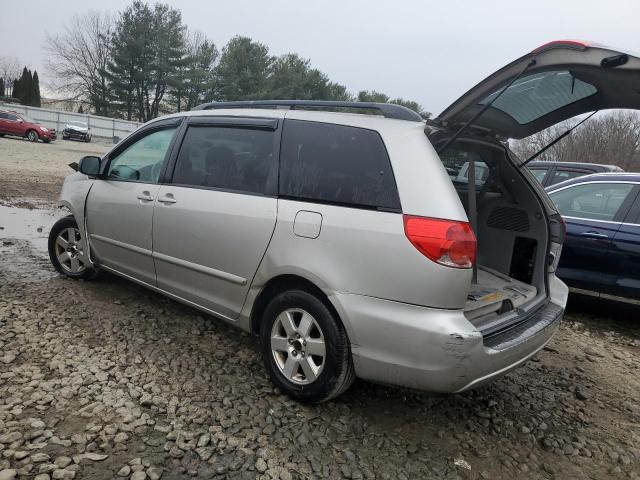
[549,183,633,221]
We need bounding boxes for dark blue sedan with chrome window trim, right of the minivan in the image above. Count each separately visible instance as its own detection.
[547,173,640,304]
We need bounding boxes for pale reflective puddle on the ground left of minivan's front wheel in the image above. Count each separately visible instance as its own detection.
[0,205,64,252]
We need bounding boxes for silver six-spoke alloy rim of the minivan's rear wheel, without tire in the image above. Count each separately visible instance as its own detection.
[271,308,326,385]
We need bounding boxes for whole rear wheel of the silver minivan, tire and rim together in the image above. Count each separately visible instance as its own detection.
[260,290,355,402]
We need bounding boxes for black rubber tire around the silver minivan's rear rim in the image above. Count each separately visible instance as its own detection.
[260,290,355,403]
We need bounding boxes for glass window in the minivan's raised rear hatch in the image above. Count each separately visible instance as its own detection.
[480,70,598,125]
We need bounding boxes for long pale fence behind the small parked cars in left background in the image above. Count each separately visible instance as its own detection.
[0,103,141,142]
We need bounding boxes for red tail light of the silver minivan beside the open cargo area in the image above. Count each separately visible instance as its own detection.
[403,215,476,268]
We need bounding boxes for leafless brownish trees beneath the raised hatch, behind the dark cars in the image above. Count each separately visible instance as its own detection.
[513,110,640,171]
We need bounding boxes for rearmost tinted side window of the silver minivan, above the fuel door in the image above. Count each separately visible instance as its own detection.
[280,120,400,210]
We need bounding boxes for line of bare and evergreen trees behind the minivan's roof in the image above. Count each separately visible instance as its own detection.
[45,0,422,122]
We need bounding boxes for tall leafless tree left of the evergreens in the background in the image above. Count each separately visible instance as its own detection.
[45,10,114,115]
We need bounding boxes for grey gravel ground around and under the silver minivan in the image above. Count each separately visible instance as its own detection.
[0,139,640,480]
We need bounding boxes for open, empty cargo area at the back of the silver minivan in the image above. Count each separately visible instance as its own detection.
[441,139,548,331]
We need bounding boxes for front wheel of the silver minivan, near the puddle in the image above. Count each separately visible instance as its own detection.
[49,216,96,279]
